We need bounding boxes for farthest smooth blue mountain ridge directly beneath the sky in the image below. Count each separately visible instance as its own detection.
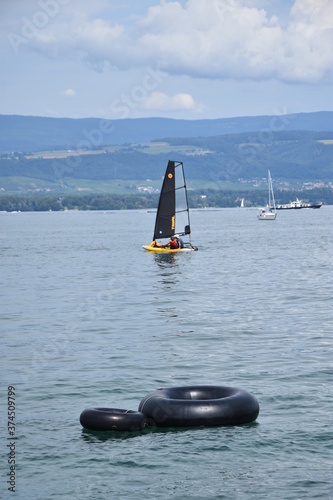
[0,111,333,154]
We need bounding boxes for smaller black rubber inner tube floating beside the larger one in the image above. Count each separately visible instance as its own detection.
[80,408,148,432]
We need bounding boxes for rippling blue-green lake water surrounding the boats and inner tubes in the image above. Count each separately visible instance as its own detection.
[0,206,333,500]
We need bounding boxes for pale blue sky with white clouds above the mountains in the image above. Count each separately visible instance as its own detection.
[0,0,333,120]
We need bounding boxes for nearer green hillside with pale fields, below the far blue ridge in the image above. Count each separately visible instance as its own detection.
[0,132,333,192]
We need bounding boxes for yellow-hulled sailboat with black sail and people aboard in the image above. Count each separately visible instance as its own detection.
[143,160,198,253]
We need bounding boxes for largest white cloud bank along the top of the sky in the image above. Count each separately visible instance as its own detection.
[3,0,333,83]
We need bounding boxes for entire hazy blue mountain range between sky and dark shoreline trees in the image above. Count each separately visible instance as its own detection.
[0,112,333,198]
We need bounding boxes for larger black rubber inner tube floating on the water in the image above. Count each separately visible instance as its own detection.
[139,385,259,427]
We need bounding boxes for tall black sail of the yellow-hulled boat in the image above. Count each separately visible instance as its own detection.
[153,161,176,240]
